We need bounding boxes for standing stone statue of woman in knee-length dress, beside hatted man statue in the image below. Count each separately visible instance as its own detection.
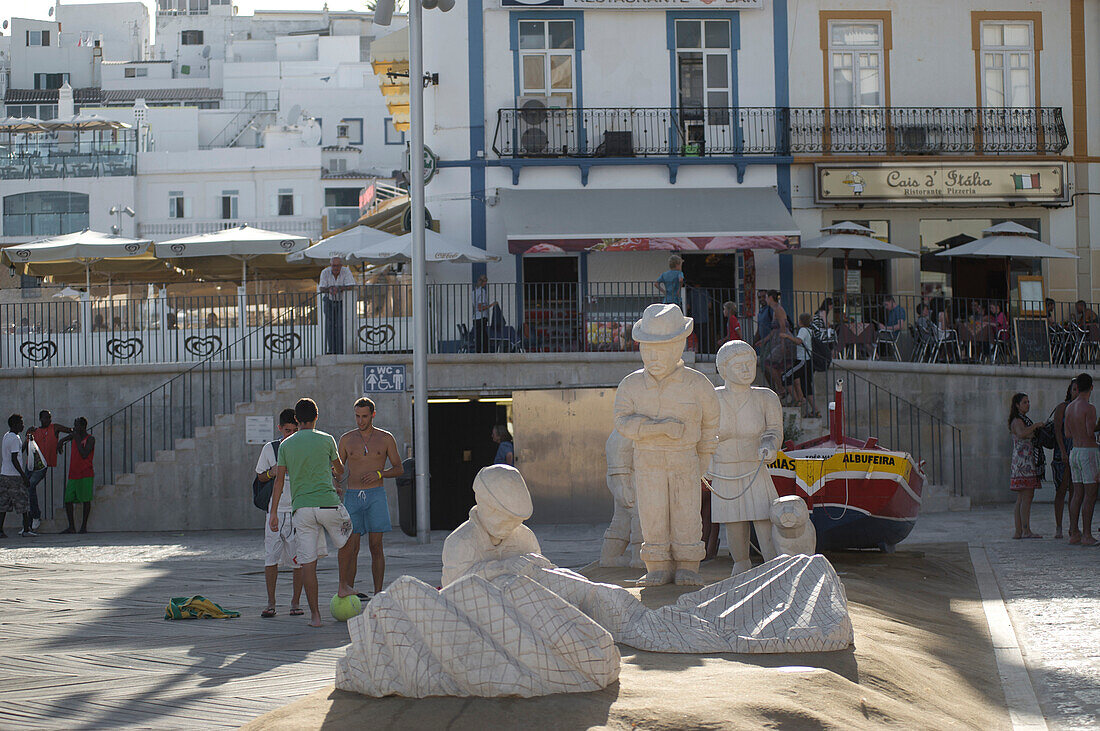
[707,340,783,575]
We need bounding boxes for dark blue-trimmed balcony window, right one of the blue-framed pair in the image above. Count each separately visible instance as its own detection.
[675,20,732,126]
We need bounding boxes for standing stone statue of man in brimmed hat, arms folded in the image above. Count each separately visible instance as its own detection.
[615,304,719,586]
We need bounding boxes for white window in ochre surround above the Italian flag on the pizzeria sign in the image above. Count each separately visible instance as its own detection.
[981,22,1035,108]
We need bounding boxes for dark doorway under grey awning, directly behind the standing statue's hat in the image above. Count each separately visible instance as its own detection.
[683,252,745,353]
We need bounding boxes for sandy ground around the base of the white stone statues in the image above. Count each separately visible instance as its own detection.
[245,544,1010,731]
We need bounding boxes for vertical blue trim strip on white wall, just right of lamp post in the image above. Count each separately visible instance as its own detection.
[466,0,486,283]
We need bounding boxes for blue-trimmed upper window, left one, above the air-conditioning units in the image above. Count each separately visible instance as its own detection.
[519,20,575,107]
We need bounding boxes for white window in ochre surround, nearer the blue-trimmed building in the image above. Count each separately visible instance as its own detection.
[828,21,886,109]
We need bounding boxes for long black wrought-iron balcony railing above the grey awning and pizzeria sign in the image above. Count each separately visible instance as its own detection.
[493,107,1069,157]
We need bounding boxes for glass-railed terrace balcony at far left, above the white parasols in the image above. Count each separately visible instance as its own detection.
[0,138,138,180]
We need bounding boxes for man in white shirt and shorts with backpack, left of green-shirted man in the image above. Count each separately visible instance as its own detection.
[256,409,328,618]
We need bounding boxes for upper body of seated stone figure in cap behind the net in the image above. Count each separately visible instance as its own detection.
[443,465,541,586]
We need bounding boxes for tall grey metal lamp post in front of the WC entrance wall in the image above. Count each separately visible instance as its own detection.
[374,0,454,543]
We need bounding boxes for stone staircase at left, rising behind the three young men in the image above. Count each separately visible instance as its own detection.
[42,366,321,532]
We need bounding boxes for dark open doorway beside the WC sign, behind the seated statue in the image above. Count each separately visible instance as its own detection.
[428,398,509,531]
